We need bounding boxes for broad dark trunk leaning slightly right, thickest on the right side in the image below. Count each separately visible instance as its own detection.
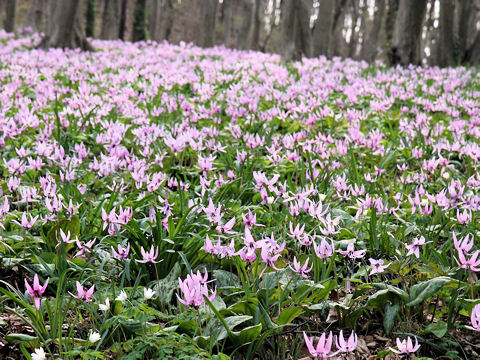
[391,0,427,66]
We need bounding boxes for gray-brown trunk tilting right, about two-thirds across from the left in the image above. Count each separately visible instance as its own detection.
[313,0,335,57]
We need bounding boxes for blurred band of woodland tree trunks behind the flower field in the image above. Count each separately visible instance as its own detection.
[0,0,480,66]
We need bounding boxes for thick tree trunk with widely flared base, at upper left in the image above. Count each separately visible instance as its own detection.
[40,0,93,50]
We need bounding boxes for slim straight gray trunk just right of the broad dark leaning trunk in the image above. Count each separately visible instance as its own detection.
[437,0,455,66]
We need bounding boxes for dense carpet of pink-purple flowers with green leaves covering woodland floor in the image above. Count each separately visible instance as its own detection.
[0,32,480,360]
